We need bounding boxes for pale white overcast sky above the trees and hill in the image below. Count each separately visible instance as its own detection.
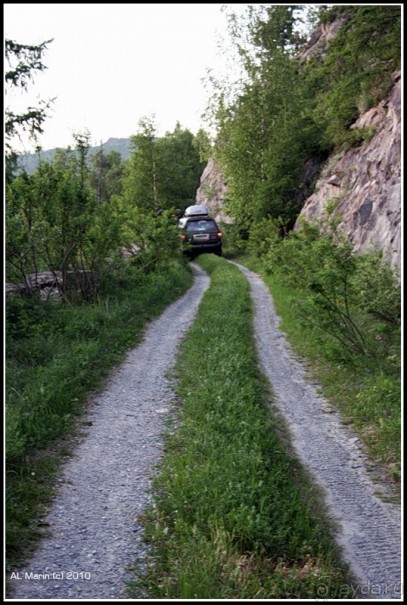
[4,3,248,151]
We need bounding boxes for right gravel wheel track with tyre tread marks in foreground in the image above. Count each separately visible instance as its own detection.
[237,265,402,599]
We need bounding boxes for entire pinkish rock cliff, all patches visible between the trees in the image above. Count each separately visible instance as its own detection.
[196,18,401,272]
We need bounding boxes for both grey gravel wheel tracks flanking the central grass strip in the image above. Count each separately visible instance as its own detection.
[10,265,401,600]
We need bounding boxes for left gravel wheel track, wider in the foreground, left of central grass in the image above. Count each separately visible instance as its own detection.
[10,265,209,600]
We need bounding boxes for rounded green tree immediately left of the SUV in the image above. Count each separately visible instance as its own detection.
[120,118,204,268]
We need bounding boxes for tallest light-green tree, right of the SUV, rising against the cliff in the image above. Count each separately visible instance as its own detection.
[215,5,317,228]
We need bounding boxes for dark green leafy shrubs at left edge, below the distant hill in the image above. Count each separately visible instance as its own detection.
[6,135,121,298]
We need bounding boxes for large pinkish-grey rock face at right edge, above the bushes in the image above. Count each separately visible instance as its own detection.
[297,73,401,270]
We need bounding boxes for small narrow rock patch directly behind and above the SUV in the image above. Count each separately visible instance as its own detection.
[196,159,232,223]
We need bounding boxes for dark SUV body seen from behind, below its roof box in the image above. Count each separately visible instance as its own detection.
[180,216,222,258]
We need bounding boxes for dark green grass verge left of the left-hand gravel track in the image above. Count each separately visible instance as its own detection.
[6,262,192,568]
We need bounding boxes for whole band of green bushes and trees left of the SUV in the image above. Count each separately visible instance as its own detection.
[6,120,203,300]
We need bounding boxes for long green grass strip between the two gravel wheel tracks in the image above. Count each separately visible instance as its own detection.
[134,255,354,599]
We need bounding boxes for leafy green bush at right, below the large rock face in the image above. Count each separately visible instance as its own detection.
[262,222,401,359]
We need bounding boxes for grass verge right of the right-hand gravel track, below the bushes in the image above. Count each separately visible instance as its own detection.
[237,257,401,492]
